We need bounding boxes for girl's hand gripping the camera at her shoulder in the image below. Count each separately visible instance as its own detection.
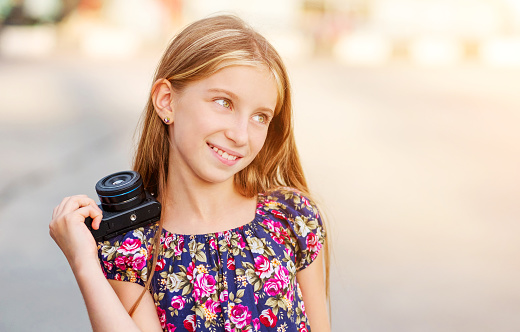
[49,195,103,269]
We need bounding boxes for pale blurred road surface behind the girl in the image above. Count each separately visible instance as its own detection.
[0,56,520,332]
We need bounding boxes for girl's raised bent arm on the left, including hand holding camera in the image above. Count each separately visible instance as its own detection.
[49,196,162,332]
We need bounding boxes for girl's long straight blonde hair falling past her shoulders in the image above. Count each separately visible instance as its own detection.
[130,15,328,314]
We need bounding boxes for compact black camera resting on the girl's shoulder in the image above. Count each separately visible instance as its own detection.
[85,171,161,241]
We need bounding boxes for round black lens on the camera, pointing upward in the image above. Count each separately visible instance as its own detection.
[96,171,146,212]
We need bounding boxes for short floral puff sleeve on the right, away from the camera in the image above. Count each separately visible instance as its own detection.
[264,188,326,271]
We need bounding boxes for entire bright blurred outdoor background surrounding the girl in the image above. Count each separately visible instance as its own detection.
[0,0,520,332]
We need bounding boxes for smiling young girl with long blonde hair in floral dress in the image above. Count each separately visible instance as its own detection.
[49,16,329,331]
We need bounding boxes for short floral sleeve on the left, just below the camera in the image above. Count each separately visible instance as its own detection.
[98,228,151,286]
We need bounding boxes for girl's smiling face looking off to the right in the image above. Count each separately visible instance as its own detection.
[170,66,278,183]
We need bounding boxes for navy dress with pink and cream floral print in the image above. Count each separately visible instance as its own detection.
[98,188,325,332]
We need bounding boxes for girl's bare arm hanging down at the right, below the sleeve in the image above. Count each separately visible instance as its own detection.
[296,250,330,332]
